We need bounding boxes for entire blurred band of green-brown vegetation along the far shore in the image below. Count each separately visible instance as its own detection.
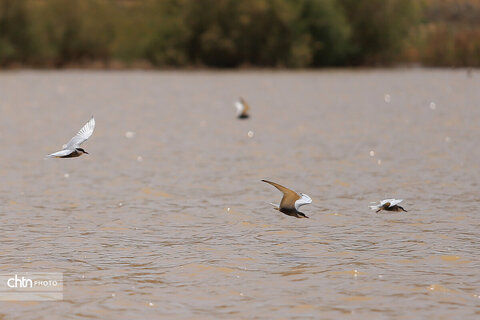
[0,0,480,68]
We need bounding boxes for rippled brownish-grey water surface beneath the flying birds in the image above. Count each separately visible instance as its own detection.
[0,69,480,319]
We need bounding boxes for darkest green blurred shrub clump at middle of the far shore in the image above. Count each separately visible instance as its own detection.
[178,0,349,67]
